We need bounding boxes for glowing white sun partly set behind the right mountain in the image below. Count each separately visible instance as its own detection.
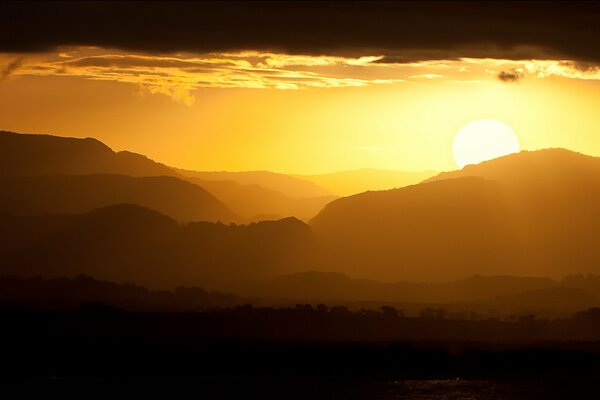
[452,119,520,168]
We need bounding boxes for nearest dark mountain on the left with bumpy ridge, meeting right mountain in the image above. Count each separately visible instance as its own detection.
[0,205,314,289]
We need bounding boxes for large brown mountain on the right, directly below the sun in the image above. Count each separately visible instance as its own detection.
[311,149,600,281]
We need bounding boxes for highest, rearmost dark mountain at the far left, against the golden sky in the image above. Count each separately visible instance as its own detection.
[0,131,177,177]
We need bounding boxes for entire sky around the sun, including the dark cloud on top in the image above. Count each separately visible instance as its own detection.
[0,2,600,174]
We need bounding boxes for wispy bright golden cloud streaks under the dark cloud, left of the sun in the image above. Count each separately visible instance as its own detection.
[7,48,404,105]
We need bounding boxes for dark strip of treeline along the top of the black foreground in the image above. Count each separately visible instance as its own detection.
[2,302,600,344]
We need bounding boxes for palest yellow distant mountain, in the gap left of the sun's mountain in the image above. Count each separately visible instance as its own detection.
[298,168,436,196]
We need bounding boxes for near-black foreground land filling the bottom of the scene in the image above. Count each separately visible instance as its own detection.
[0,304,600,399]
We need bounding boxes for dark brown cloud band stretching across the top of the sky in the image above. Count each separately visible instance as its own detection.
[0,2,600,64]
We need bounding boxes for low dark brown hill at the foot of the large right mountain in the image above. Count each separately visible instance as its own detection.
[240,271,600,319]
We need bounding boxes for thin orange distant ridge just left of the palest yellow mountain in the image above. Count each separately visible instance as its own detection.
[176,169,334,198]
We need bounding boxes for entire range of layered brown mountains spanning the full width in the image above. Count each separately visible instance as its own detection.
[0,132,600,310]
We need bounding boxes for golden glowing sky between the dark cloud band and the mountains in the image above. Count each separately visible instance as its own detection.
[0,47,600,174]
